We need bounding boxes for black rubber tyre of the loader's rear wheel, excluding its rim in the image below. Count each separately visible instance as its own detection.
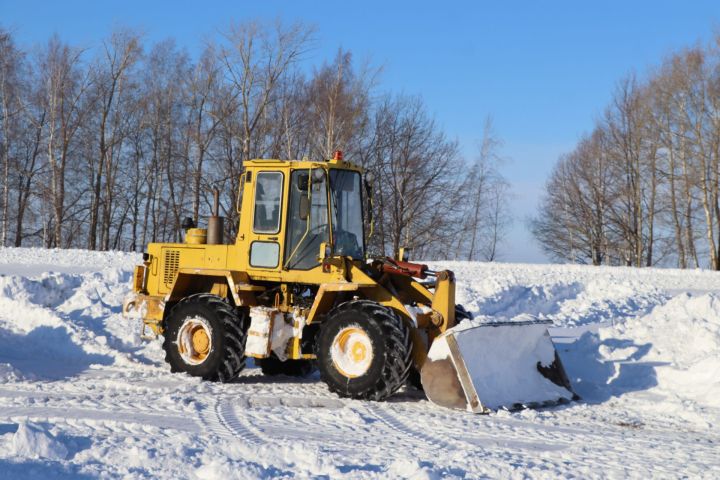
[163,293,247,382]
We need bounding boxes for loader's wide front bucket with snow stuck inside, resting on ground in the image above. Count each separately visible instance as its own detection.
[420,321,577,413]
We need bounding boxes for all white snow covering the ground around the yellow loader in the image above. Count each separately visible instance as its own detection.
[0,249,720,479]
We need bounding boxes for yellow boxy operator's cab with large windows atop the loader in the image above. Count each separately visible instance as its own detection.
[236,159,365,278]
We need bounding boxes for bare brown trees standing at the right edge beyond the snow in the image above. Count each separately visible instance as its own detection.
[532,37,720,270]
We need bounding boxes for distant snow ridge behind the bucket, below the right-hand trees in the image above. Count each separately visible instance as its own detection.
[430,262,720,326]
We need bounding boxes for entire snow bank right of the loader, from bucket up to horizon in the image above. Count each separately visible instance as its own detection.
[433,262,720,417]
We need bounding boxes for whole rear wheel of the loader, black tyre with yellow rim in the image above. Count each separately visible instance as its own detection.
[163,293,247,382]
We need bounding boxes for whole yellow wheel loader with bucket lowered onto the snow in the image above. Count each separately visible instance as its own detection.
[123,152,574,412]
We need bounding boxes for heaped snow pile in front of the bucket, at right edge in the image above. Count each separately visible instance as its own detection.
[563,293,720,410]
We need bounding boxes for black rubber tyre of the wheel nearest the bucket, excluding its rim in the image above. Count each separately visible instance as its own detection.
[316,300,412,401]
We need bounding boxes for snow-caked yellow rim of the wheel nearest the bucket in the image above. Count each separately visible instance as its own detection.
[330,326,373,378]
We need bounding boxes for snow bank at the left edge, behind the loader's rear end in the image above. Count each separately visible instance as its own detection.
[0,248,158,383]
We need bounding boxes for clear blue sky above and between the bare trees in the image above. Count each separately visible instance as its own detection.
[0,0,720,262]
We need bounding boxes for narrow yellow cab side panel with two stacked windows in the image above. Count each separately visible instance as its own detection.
[248,170,286,271]
